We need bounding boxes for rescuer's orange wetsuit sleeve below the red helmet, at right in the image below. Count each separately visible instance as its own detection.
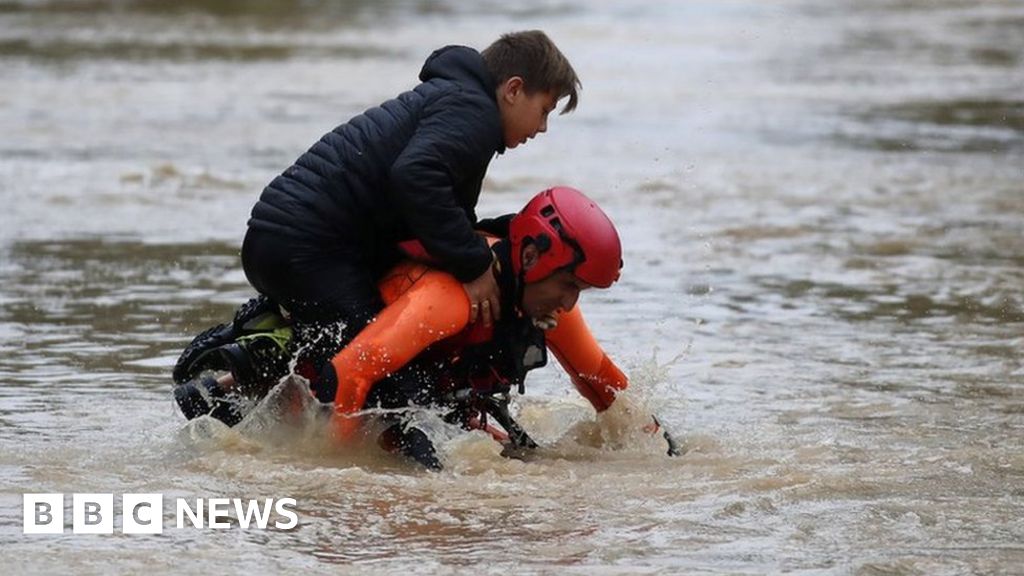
[547,306,629,412]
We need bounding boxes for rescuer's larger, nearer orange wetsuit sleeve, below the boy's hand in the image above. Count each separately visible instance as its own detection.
[331,268,469,439]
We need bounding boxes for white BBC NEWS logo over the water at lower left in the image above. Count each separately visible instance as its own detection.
[23,494,299,534]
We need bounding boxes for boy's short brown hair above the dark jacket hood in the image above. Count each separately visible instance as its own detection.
[480,30,583,114]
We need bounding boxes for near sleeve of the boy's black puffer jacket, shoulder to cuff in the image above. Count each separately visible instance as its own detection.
[388,92,500,282]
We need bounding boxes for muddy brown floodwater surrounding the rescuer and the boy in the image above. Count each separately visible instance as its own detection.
[0,0,1024,575]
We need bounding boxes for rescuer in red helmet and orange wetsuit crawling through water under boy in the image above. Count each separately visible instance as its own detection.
[176,187,680,468]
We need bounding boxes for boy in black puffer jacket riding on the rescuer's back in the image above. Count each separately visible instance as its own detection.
[235,31,581,375]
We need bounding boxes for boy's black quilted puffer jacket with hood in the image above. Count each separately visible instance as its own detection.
[249,46,505,282]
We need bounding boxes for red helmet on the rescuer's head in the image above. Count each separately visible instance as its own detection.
[509,187,623,288]
